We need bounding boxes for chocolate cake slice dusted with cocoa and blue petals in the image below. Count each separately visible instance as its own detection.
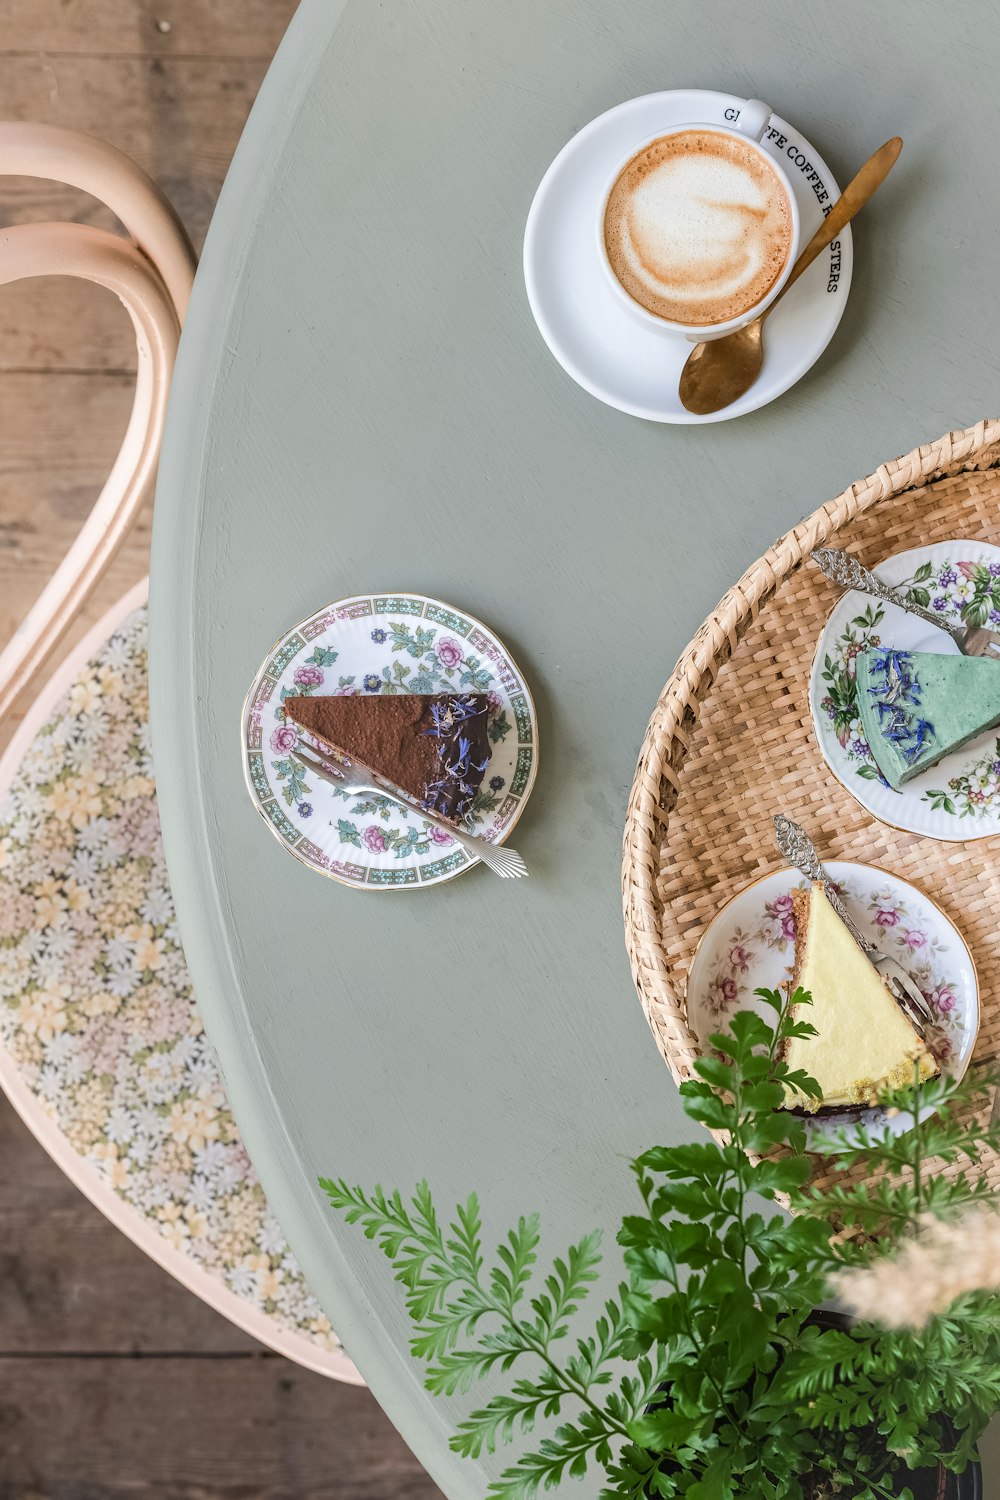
[283,693,490,827]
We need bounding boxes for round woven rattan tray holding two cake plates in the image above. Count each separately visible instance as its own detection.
[622,420,1000,1182]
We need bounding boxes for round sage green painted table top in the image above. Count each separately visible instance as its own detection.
[151,0,1000,1500]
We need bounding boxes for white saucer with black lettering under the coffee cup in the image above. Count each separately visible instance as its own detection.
[525,89,855,423]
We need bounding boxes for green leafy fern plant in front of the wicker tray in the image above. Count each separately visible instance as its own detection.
[321,990,1000,1500]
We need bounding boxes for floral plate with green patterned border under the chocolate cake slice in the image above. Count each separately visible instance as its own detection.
[240,594,538,891]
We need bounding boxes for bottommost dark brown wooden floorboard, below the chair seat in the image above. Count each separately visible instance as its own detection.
[0,1356,439,1500]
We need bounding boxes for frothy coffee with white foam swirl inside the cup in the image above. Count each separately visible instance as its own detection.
[604,131,792,327]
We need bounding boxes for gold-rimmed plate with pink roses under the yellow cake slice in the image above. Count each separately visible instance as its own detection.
[687,860,979,1136]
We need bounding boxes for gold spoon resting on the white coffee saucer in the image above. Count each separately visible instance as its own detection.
[679,135,903,417]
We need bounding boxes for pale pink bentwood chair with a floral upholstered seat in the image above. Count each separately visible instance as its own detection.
[0,123,363,1385]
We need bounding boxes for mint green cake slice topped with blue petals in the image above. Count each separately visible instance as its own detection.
[855,647,1000,791]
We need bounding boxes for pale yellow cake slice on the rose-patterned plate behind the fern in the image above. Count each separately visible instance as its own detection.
[783,884,937,1113]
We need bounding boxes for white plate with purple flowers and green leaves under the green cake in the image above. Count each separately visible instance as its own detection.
[810,542,1000,840]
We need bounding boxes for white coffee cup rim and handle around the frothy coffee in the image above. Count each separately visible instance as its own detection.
[597,99,801,344]
